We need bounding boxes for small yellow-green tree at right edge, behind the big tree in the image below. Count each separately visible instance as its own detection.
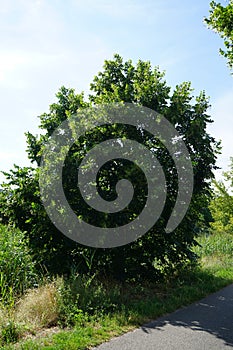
[210,158,233,234]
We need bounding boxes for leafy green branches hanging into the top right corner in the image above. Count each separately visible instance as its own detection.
[205,0,233,68]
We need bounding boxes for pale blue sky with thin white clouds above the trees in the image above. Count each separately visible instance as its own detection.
[0,0,233,181]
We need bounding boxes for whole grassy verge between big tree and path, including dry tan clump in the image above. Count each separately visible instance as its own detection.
[0,233,233,350]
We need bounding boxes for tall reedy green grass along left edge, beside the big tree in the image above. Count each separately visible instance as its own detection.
[0,225,38,345]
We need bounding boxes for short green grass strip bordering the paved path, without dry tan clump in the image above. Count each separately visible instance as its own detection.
[1,234,233,350]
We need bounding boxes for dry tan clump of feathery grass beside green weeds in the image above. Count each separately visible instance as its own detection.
[15,283,58,329]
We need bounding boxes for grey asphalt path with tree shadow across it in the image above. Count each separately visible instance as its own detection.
[92,285,233,350]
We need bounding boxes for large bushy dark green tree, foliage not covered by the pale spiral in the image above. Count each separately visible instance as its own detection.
[0,55,218,278]
